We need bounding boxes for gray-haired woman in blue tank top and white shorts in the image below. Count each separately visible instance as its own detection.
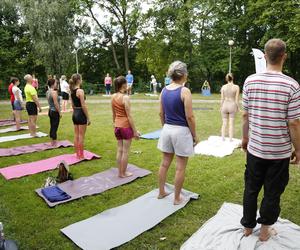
[157,61,198,205]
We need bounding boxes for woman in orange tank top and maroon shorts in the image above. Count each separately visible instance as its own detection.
[111,76,140,178]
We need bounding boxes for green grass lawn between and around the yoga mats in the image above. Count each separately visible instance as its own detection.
[0,96,300,250]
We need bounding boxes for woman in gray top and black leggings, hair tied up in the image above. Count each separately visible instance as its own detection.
[46,79,61,146]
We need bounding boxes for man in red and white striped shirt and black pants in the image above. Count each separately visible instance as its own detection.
[241,39,300,241]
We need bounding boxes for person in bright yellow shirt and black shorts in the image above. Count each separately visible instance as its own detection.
[24,74,42,137]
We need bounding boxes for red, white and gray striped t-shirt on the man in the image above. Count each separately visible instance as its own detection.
[243,73,300,159]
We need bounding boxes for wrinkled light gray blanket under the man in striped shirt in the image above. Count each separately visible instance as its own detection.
[180,203,300,250]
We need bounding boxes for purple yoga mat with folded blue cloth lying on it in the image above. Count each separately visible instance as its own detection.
[35,164,151,207]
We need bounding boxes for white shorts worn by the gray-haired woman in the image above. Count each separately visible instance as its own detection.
[157,124,194,157]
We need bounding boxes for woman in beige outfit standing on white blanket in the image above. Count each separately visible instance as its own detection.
[221,73,240,141]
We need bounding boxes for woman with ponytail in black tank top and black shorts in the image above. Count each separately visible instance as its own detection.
[69,74,91,159]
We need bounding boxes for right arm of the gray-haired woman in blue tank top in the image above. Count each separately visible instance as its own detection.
[181,87,199,143]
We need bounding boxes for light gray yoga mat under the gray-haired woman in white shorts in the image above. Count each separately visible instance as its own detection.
[61,184,199,250]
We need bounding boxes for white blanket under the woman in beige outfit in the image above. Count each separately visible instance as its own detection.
[194,136,242,157]
